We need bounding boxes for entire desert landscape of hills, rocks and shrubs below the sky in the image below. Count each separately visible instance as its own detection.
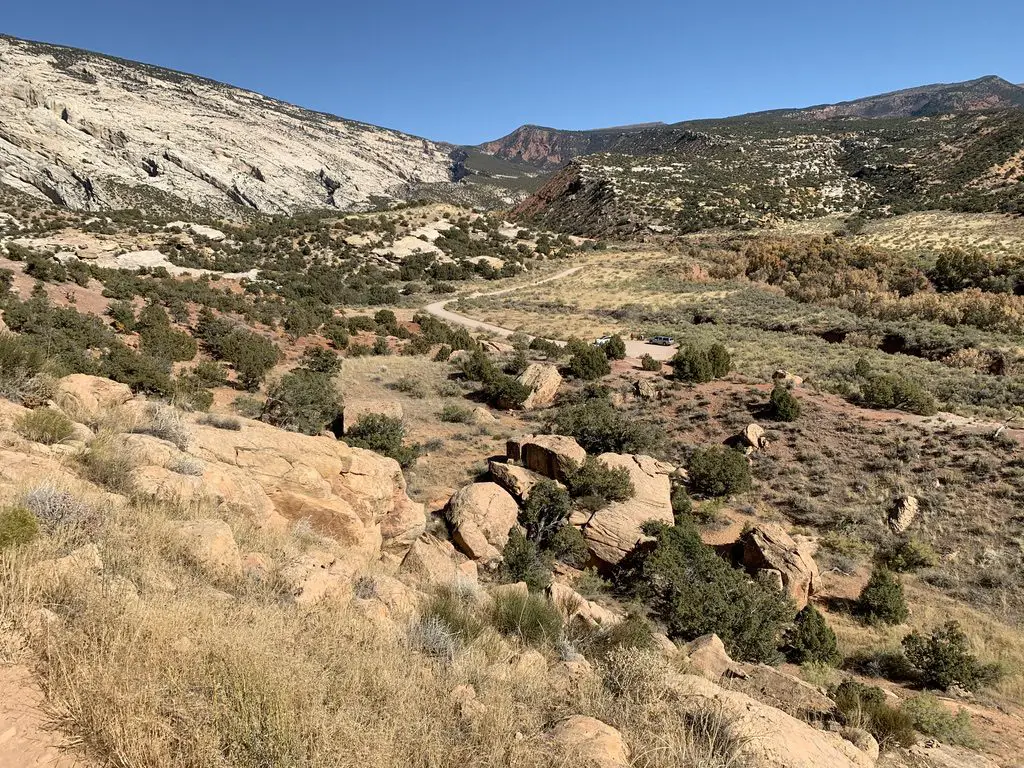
[0,28,1024,768]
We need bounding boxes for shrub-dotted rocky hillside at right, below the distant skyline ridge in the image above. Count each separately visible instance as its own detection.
[515,111,1024,237]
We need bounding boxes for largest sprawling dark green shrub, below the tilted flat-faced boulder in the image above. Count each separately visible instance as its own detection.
[616,523,795,664]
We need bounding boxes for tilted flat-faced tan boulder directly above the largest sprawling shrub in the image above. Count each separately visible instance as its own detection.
[584,454,675,565]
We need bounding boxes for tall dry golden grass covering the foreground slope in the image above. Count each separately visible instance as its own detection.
[0,489,753,768]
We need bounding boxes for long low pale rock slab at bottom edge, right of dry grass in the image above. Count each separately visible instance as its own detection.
[673,675,874,768]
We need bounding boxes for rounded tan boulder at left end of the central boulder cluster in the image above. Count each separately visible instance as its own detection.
[445,482,519,561]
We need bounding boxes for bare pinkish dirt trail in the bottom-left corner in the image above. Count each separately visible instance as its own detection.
[0,665,90,768]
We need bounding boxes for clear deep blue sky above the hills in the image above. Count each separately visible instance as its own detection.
[0,0,1024,143]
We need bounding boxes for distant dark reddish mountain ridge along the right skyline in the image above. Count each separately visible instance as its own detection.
[477,76,1024,170]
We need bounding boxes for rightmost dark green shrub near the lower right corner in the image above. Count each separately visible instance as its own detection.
[903,622,1000,690]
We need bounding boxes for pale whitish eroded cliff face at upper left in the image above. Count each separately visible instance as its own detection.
[0,38,452,213]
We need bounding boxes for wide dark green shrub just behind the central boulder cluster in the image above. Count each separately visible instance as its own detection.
[550,397,662,454]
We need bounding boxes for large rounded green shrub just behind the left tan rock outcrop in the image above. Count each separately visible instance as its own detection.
[260,368,343,435]
